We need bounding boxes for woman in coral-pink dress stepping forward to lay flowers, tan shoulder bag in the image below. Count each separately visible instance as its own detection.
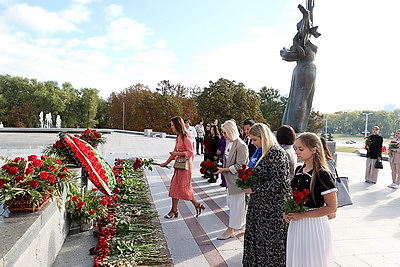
[160,117,205,219]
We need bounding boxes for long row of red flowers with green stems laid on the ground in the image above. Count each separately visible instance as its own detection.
[90,159,171,266]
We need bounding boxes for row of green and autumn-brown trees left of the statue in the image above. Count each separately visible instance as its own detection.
[0,75,324,133]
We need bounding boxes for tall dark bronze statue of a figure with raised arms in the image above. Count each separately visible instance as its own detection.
[280,0,321,133]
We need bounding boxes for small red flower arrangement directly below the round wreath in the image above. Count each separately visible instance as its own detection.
[65,186,108,223]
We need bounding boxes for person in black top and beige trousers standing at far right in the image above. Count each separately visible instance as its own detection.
[365,126,383,184]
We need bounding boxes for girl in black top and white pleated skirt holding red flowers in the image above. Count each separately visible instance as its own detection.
[285,133,337,267]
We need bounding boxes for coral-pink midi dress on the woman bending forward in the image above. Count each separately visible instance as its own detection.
[169,136,194,200]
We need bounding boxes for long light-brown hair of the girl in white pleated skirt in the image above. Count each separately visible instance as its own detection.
[297,132,330,200]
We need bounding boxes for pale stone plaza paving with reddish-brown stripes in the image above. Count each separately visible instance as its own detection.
[0,133,400,267]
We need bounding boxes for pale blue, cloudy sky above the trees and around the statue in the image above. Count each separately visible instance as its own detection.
[0,0,400,113]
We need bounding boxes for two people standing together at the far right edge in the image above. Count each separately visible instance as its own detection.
[365,126,400,189]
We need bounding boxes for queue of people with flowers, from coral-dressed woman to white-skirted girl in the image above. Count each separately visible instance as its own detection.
[160,117,337,267]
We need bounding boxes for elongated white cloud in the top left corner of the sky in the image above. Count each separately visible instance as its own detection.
[4,4,77,34]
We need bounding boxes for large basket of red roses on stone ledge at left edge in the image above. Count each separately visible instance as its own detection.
[0,155,74,209]
